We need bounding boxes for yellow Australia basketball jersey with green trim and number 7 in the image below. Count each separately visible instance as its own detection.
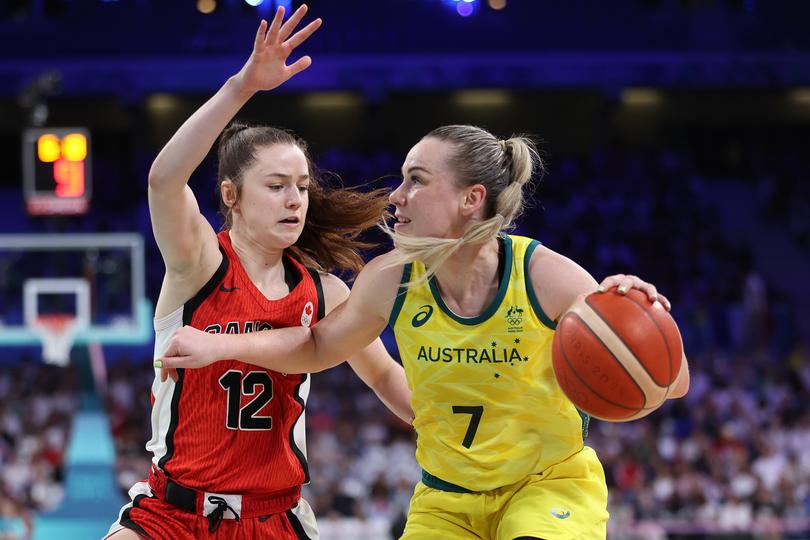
[390,235,587,491]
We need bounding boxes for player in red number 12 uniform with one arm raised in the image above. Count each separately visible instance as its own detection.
[108,6,412,540]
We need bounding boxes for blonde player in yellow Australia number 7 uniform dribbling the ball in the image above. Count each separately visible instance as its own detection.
[159,126,689,540]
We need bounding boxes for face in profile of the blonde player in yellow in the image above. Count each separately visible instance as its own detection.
[388,138,467,238]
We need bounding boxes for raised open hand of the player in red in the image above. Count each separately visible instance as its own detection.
[236,4,322,93]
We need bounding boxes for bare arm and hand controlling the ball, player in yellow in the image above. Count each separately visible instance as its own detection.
[529,245,689,399]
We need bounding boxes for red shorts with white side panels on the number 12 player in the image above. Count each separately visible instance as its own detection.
[102,483,318,540]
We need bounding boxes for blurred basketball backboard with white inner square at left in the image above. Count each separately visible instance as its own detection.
[0,233,152,354]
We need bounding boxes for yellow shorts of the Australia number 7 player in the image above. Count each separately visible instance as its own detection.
[402,446,608,540]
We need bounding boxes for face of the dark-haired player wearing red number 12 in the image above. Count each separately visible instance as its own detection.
[234,144,310,248]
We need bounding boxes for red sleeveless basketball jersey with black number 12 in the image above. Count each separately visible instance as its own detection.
[147,231,323,494]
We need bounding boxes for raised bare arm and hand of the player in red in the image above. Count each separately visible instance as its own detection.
[149,6,321,317]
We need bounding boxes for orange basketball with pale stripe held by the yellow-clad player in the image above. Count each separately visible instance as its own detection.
[551,289,683,422]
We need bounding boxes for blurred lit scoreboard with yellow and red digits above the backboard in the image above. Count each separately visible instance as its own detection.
[23,128,92,216]
